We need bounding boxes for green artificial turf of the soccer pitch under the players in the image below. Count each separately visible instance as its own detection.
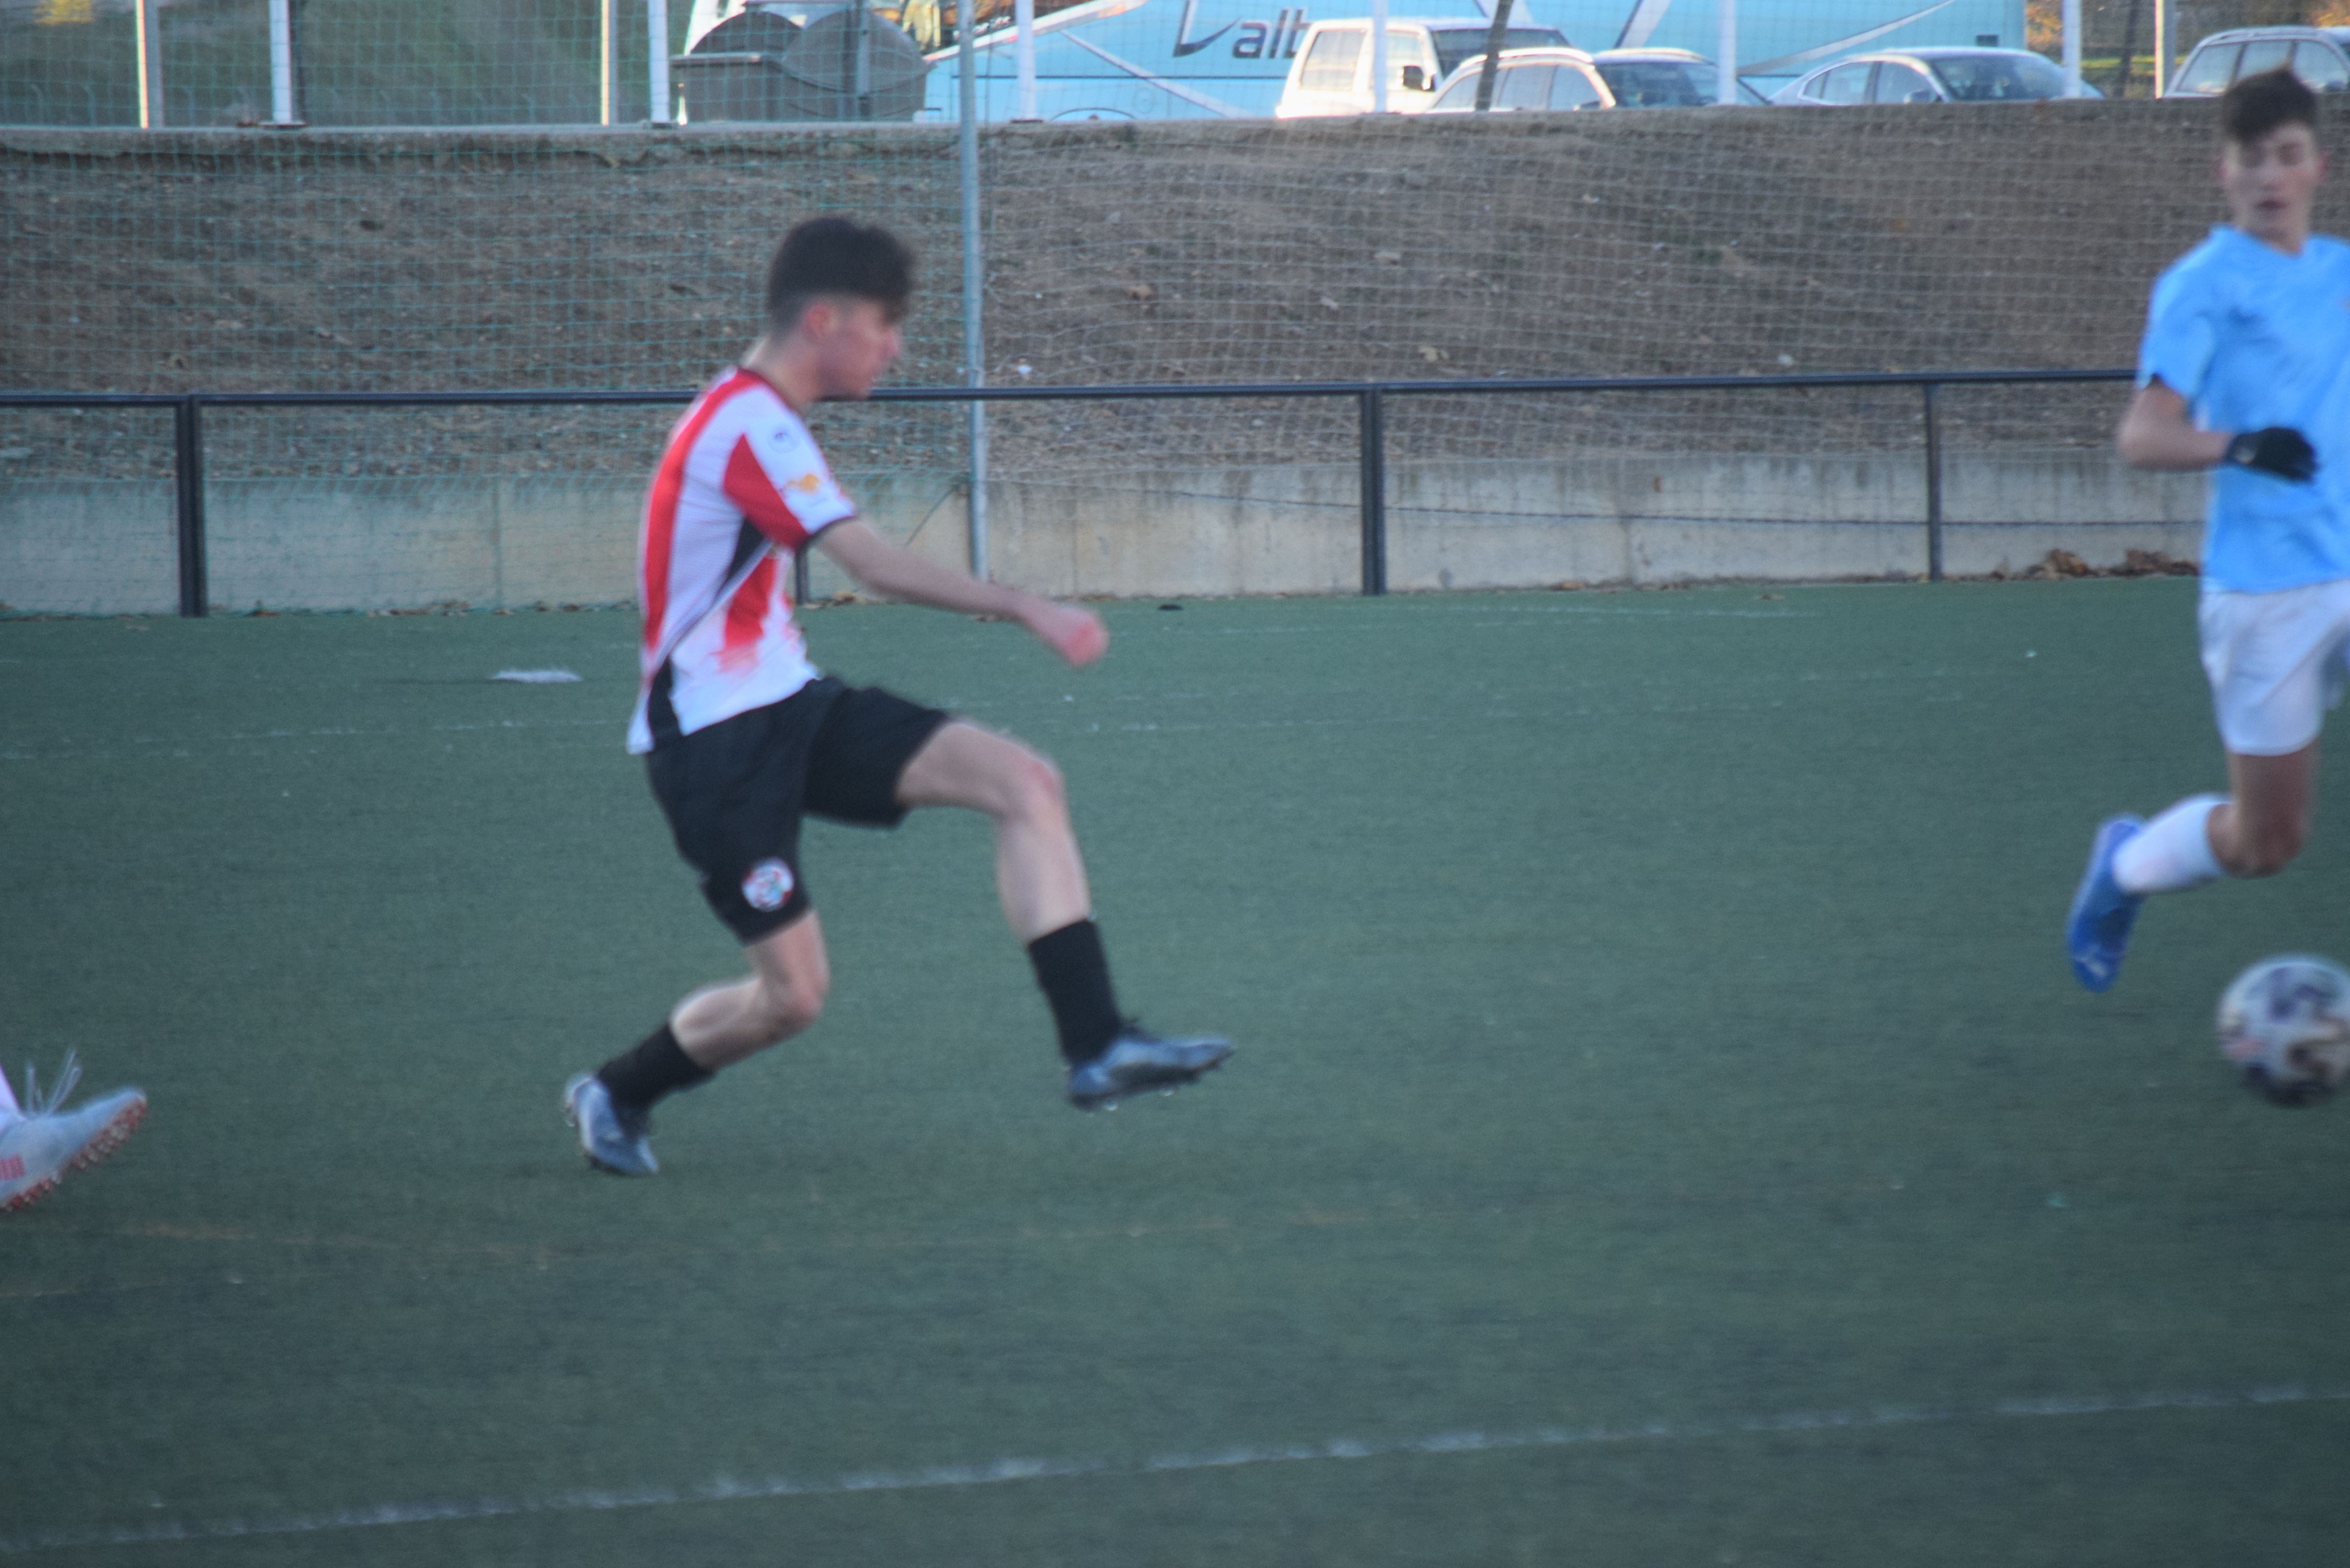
[0,581,2350,1568]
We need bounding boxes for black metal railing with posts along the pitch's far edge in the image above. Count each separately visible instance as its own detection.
[0,369,2132,616]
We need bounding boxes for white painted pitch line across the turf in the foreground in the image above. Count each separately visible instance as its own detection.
[0,1385,2350,1557]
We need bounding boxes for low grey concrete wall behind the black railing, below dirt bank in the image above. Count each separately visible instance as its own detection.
[0,449,2202,614]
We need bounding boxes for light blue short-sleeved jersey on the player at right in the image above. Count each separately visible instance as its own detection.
[2138,228,2350,592]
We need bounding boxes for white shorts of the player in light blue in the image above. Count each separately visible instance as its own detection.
[2195,578,2350,757]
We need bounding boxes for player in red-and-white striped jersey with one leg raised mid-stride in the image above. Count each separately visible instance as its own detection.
[564,218,1231,1175]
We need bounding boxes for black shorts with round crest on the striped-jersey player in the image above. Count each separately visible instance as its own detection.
[644,677,954,945]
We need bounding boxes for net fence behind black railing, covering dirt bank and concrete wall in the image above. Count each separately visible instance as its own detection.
[0,87,2275,609]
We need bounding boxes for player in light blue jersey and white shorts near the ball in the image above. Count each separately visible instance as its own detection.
[2066,71,2350,992]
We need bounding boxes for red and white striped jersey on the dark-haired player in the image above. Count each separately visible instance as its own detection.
[627,369,856,752]
